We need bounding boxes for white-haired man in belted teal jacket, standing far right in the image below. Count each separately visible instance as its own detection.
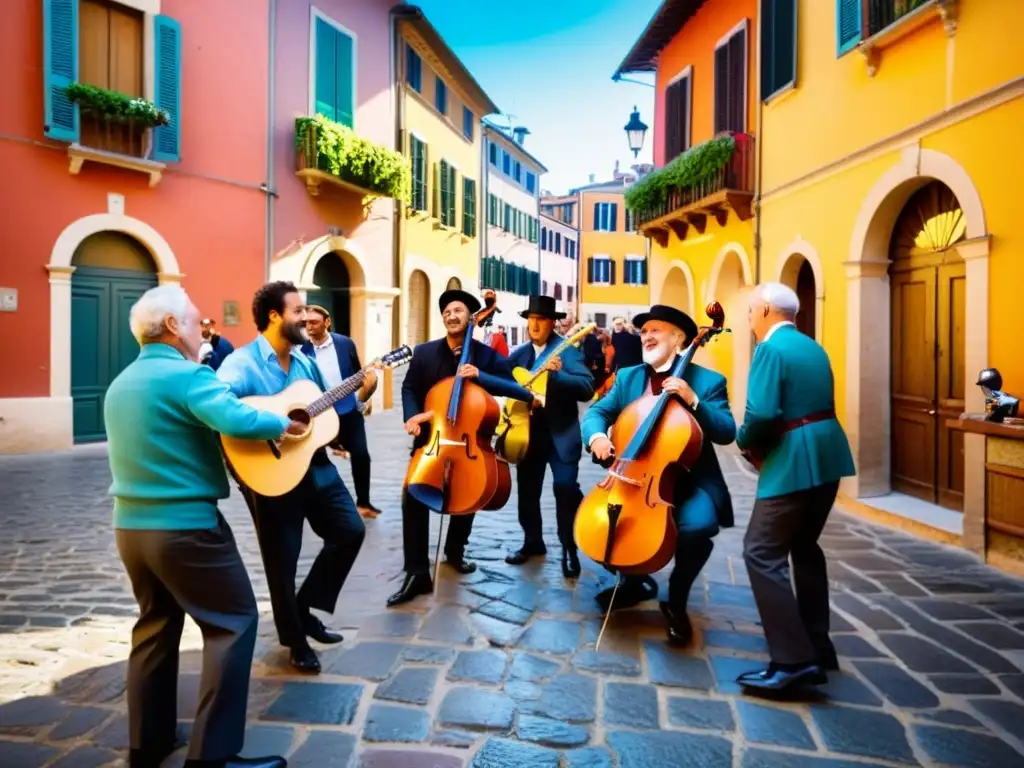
[736,283,856,690]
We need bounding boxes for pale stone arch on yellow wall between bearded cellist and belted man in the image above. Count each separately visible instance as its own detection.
[693,242,754,424]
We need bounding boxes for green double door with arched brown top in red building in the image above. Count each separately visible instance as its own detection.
[71,231,157,442]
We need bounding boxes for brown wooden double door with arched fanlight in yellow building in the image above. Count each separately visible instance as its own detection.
[889,181,967,510]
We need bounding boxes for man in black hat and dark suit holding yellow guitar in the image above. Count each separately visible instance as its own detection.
[505,296,594,579]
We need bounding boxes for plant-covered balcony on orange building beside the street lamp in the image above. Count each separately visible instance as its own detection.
[626,132,754,248]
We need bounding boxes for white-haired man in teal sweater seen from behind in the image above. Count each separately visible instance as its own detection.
[103,286,292,768]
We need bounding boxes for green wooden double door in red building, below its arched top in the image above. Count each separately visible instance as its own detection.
[71,266,157,442]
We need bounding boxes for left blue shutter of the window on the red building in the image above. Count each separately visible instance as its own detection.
[43,0,80,141]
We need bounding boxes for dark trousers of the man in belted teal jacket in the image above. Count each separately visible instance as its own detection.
[743,482,839,665]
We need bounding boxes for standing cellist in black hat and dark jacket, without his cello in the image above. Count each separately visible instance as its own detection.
[387,290,544,607]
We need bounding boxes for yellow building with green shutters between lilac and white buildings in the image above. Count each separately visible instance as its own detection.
[394,5,498,344]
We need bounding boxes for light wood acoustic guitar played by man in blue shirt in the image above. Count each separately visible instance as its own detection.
[220,346,413,497]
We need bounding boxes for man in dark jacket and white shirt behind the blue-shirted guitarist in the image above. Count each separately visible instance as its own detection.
[302,305,381,518]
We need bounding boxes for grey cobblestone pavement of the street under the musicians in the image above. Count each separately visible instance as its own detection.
[0,393,1024,768]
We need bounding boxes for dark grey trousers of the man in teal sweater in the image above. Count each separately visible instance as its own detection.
[116,514,259,760]
